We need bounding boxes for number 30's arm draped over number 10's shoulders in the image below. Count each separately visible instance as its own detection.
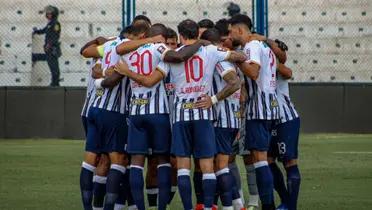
[163,40,210,63]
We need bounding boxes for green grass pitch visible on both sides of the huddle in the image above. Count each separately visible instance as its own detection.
[0,134,372,210]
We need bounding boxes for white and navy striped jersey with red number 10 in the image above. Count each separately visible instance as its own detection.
[158,45,230,123]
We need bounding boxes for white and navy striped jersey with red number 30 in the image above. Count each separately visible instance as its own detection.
[123,43,169,115]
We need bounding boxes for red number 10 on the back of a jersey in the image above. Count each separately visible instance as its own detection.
[185,55,204,83]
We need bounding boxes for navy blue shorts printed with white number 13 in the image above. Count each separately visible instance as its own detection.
[269,118,300,162]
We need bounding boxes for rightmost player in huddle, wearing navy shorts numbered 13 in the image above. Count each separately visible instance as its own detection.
[269,63,301,210]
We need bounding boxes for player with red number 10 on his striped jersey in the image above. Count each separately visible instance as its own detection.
[118,20,245,209]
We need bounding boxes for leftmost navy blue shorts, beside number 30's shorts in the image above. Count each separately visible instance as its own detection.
[85,107,128,153]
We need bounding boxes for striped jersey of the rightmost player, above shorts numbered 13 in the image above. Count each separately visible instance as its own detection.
[276,74,299,123]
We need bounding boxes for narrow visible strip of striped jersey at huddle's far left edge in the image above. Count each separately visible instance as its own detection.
[81,58,101,117]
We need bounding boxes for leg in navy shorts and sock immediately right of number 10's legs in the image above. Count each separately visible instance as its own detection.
[214,128,238,209]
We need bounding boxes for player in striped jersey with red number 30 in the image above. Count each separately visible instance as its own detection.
[103,24,208,209]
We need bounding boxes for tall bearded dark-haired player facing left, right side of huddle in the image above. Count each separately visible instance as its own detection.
[230,15,279,210]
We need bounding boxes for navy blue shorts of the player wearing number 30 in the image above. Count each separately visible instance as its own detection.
[127,114,171,155]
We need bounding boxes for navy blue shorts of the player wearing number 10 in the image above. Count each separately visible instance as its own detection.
[171,120,217,159]
